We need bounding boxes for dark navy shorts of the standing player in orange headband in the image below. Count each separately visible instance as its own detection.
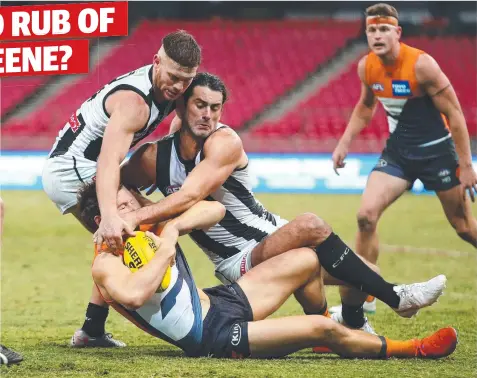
[373,139,460,192]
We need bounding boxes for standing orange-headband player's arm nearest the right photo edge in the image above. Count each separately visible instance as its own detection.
[415,54,477,201]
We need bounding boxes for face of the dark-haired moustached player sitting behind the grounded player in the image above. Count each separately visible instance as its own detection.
[185,86,223,138]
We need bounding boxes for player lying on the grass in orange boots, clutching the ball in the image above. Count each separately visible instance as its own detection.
[80,184,457,358]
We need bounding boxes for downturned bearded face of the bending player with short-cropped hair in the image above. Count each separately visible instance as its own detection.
[154,56,197,101]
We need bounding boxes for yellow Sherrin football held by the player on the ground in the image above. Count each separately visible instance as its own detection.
[123,231,171,293]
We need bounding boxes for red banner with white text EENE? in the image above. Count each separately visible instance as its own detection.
[0,40,89,77]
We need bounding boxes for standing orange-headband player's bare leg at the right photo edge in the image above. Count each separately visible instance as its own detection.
[437,185,477,248]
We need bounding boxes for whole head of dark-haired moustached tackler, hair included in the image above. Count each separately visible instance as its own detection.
[180,72,227,138]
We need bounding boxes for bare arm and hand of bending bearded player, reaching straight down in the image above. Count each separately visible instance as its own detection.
[95,91,149,249]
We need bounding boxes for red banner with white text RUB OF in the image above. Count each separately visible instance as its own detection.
[0,1,128,41]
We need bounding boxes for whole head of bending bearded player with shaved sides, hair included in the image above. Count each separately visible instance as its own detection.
[154,30,201,101]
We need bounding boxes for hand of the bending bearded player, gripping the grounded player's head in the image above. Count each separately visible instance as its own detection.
[93,214,136,253]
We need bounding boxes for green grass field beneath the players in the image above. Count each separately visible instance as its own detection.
[0,192,477,377]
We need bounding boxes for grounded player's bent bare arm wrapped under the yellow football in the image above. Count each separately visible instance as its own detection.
[92,228,179,310]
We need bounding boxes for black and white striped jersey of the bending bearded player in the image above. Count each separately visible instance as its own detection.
[50,64,175,161]
